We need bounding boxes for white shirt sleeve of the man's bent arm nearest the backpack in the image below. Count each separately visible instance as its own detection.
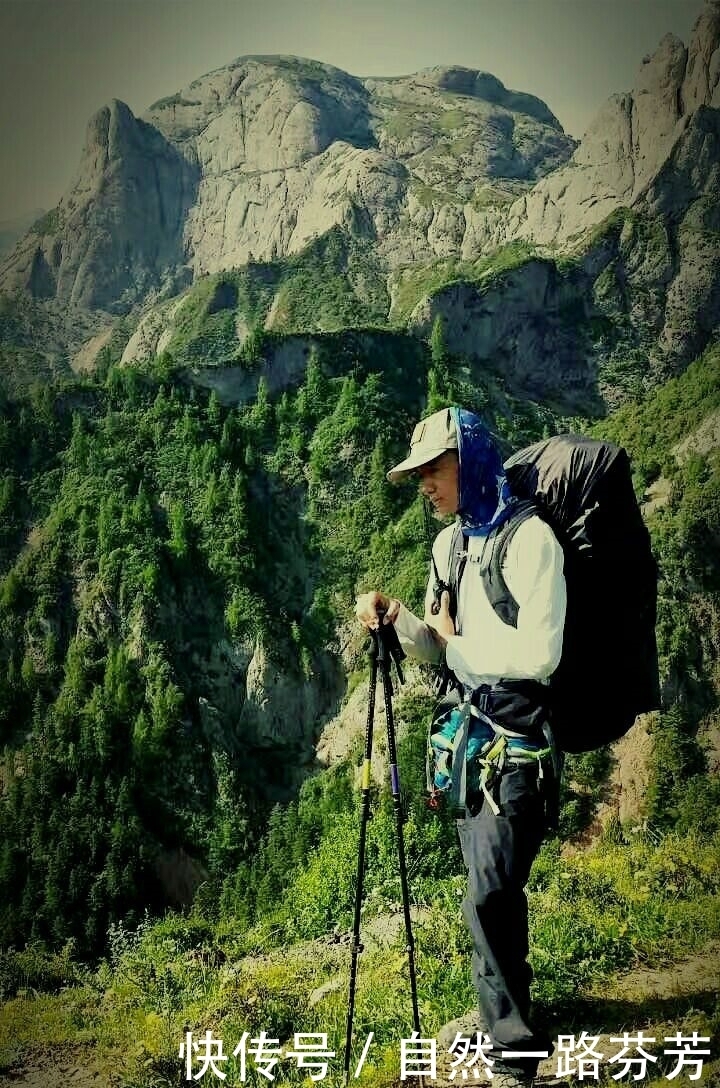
[447,518,567,681]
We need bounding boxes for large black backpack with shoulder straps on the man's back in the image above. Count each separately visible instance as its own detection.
[448,434,660,752]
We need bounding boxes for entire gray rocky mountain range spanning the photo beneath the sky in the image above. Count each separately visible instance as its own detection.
[0,10,720,393]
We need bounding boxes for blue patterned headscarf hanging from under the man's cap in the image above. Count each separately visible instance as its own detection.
[450,408,518,536]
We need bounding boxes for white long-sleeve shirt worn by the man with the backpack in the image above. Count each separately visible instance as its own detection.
[395,517,567,689]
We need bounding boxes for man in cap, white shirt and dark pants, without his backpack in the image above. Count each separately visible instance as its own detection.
[356,408,566,1088]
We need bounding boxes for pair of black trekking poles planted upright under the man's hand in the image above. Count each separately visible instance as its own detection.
[345,617,420,1085]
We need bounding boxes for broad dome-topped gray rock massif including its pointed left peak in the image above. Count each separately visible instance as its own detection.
[0,57,574,310]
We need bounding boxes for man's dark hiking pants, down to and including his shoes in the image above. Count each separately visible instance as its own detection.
[458,764,551,1074]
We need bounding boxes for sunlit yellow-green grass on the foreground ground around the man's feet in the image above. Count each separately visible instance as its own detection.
[0,833,720,1088]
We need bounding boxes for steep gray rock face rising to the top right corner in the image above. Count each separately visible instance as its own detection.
[413,0,720,391]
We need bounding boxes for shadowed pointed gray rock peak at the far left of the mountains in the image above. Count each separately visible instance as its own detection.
[0,101,198,310]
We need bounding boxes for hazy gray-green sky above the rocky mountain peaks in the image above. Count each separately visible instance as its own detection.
[0,0,704,221]
